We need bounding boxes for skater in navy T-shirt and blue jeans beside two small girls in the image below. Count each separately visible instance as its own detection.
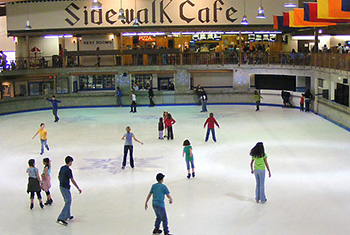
[57,156,82,226]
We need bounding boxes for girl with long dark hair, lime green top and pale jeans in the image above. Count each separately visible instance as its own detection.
[250,142,271,204]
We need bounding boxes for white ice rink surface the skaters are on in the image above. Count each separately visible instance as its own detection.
[0,105,350,235]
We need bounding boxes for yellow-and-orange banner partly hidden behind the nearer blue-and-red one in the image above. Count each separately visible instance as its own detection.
[289,8,336,28]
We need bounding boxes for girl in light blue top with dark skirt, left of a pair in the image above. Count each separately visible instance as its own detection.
[27,159,44,210]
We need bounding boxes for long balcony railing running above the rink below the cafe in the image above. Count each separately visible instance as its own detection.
[1,49,350,71]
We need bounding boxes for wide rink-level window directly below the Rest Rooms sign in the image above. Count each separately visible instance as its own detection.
[79,75,115,90]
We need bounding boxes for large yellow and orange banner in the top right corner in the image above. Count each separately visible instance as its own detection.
[317,0,350,19]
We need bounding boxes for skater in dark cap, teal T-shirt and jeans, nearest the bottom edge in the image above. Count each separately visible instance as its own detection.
[145,173,173,235]
